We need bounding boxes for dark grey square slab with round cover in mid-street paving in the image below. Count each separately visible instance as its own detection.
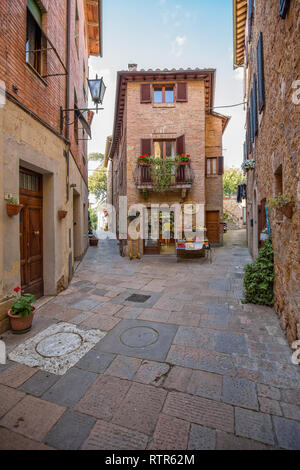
[97,320,177,361]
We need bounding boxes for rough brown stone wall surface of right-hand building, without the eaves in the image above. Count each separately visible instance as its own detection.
[248,0,300,342]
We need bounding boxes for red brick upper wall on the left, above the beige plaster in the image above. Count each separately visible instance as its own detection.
[0,0,88,184]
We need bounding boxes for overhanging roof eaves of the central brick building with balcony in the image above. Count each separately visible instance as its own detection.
[110,68,216,156]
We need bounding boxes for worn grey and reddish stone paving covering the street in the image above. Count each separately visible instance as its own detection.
[0,231,300,450]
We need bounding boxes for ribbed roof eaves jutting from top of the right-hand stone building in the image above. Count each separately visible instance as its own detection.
[233,0,248,68]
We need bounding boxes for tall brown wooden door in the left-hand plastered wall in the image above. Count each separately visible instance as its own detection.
[20,169,44,298]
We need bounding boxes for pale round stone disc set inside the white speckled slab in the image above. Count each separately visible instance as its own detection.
[35,333,82,357]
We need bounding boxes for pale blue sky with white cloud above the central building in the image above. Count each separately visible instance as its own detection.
[89,0,245,172]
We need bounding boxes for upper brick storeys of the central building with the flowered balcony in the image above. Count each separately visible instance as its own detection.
[106,67,229,254]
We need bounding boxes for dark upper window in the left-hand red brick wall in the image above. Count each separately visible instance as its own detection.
[26,0,43,75]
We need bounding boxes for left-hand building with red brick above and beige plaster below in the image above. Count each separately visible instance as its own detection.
[0,0,102,331]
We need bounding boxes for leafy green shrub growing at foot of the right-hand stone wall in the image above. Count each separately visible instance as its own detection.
[244,239,275,306]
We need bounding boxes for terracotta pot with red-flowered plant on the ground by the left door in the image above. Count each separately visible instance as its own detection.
[7,287,36,334]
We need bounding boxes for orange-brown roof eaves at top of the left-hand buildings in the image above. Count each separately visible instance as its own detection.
[85,0,103,57]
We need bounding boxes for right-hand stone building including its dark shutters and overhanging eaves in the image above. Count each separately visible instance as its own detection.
[233,0,300,342]
